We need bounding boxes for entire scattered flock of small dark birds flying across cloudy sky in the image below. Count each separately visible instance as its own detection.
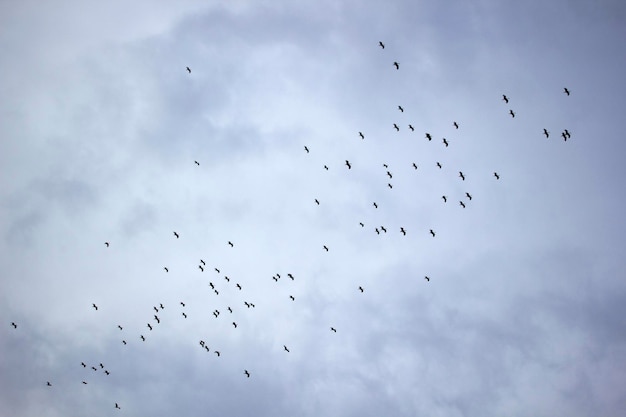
[6,41,571,409]
